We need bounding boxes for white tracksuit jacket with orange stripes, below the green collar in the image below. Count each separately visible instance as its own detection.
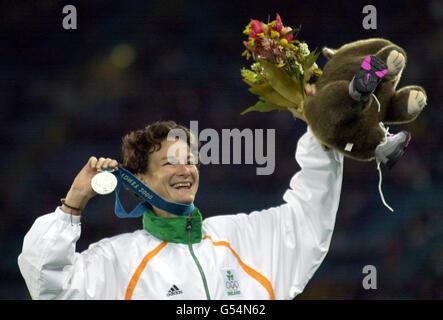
[18,128,343,300]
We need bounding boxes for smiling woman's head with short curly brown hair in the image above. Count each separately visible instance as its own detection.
[122,121,199,217]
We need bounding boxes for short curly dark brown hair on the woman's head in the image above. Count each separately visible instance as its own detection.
[122,120,200,174]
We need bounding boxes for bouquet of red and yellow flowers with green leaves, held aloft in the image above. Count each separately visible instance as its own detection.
[241,14,322,120]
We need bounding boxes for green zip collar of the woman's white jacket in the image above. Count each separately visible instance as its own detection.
[143,207,202,244]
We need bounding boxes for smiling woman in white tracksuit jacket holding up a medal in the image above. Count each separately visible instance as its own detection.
[18,121,343,300]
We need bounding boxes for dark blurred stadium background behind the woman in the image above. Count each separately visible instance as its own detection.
[0,0,443,299]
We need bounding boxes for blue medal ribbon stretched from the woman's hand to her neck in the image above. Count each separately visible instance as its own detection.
[112,166,195,218]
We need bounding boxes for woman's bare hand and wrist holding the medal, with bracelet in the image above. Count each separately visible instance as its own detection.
[62,157,118,215]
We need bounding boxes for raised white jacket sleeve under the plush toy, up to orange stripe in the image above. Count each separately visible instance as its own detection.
[207,128,343,299]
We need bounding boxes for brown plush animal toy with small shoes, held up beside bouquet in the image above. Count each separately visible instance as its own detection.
[304,38,426,168]
